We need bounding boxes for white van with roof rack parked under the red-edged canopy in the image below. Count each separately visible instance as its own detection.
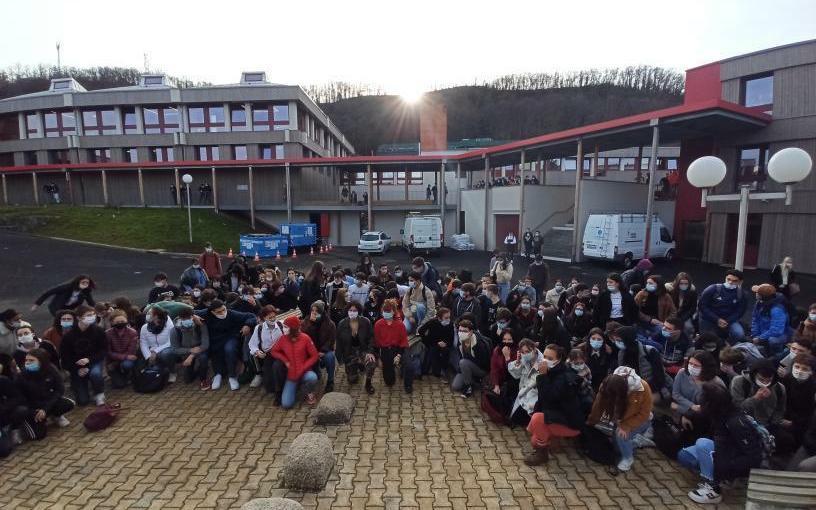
[582,214,675,269]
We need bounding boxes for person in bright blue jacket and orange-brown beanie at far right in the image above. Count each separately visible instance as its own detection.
[751,283,791,357]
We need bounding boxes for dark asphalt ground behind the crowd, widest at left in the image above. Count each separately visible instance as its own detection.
[0,231,816,330]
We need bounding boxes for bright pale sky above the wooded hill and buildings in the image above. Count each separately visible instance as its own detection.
[0,0,816,95]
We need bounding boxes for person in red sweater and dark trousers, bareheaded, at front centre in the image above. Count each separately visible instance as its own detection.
[374,300,414,394]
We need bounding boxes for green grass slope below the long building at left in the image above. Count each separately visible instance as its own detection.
[0,205,251,253]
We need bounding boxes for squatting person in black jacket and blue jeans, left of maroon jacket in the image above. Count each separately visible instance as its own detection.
[60,305,107,406]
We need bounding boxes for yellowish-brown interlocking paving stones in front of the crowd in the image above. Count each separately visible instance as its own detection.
[0,371,745,510]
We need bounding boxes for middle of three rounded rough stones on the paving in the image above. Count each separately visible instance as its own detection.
[283,432,334,492]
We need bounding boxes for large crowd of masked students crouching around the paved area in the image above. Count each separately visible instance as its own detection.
[0,246,816,503]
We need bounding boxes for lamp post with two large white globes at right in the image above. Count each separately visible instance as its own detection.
[686,147,813,271]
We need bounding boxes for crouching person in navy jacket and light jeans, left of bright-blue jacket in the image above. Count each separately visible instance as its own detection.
[697,269,748,345]
